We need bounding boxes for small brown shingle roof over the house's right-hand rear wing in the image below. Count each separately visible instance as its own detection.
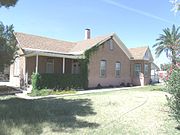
[129,47,148,60]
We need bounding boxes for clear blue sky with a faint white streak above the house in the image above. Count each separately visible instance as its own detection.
[0,0,180,65]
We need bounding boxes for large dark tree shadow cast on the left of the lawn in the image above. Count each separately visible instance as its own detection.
[0,98,99,135]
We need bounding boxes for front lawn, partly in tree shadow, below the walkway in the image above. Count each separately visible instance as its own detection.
[0,86,180,135]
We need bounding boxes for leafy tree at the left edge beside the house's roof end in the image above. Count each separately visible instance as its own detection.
[0,22,18,71]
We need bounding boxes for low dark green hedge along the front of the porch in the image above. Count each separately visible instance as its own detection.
[32,74,84,90]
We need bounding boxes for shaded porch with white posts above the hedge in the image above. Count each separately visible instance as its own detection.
[24,55,80,84]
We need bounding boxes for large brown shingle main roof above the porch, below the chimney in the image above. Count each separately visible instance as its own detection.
[15,32,111,54]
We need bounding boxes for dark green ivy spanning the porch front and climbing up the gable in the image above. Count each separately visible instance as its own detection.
[31,44,99,90]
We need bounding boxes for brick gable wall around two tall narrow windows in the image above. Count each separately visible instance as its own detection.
[88,41,131,87]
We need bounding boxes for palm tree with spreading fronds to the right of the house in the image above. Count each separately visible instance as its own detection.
[153,25,180,65]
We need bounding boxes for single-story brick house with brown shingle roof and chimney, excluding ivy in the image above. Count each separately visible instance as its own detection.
[10,29,153,88]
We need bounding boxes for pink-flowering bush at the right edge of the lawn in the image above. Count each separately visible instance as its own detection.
[166,69,180,124]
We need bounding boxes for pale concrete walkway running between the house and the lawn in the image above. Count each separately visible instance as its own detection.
[16,86,146,99]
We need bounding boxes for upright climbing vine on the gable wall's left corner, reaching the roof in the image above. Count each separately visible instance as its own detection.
[79,44,99,89]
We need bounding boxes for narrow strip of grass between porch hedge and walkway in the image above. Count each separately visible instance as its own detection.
[28,89,76,97]
